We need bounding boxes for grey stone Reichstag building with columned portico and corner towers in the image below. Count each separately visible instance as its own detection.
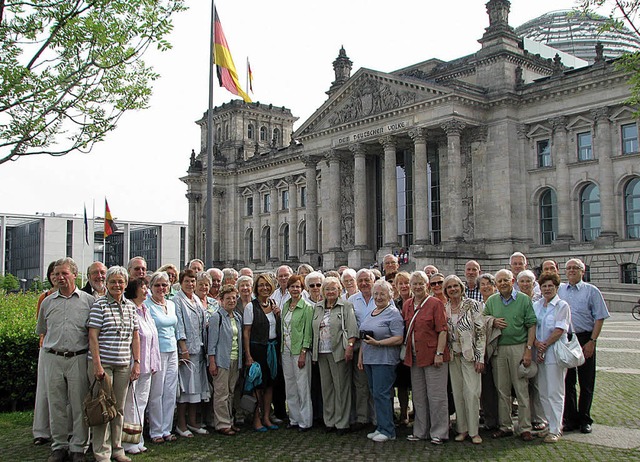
[182,0,640,308]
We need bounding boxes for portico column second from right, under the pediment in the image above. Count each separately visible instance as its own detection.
[409,128,431,245]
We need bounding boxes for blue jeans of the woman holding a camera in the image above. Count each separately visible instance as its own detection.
[364,364,396,438]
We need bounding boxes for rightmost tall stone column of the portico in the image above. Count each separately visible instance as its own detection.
[440,119,466,241]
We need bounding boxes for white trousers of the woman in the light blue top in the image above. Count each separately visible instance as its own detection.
[147,351,178,439]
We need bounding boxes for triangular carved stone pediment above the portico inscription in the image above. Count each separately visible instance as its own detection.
[296,69,452,138]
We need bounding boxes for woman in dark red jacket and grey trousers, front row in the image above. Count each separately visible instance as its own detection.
[402,271,449,445]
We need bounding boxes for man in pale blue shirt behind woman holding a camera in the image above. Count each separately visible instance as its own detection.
[348,268,376,430]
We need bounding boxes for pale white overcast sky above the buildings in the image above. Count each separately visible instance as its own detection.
[0,0,592,223]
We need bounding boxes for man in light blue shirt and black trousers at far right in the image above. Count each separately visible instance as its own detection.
[558,258,609,433]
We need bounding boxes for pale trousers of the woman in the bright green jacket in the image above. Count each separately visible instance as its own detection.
[282,349,313,428]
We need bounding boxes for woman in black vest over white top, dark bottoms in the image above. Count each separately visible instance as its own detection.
[243,273,281,432]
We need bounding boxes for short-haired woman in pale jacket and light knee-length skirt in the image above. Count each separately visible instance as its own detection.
[173,269,210,438]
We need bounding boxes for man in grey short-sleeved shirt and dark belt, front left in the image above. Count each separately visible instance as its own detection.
[36,258,95,462]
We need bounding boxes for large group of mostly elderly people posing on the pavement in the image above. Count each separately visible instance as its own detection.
[33,252,609,462]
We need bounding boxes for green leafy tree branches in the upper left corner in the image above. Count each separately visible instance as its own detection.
[0,0,186,164]
